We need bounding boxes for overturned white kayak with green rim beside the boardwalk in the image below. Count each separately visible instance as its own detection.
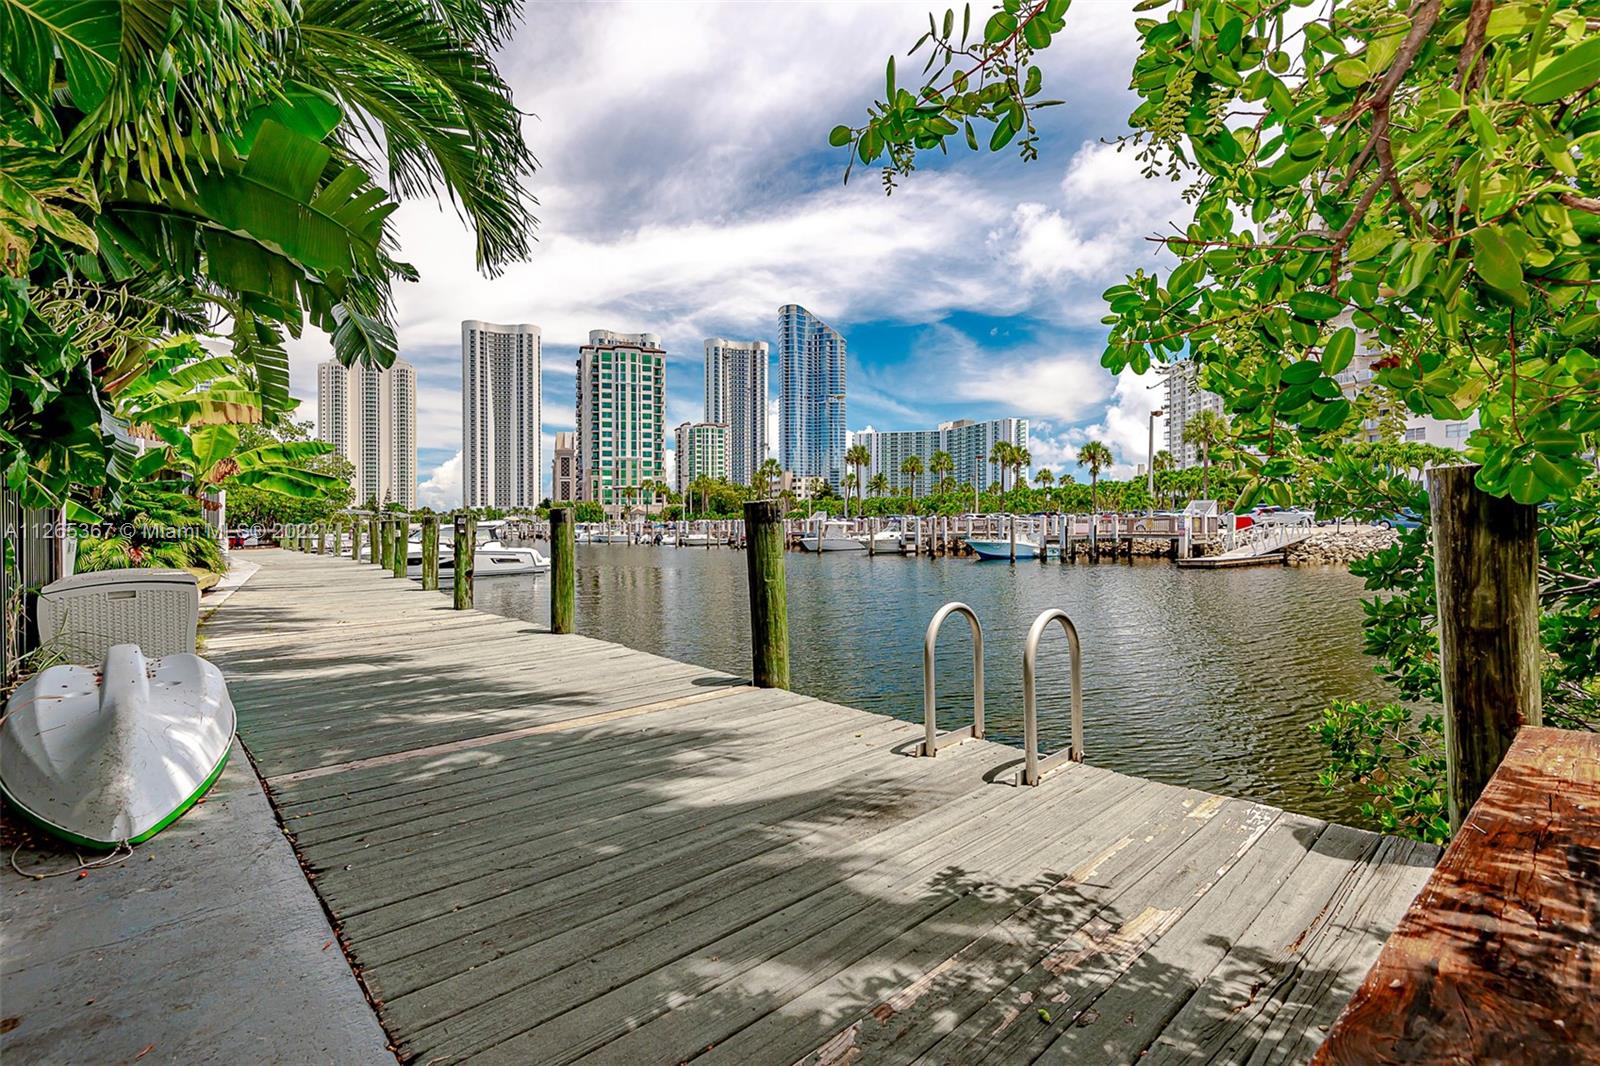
[0,643,234,848]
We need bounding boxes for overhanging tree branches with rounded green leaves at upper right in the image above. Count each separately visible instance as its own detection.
[829,0,1600,504]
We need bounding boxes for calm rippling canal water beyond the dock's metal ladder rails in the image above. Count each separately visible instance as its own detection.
[464,544,1386,821]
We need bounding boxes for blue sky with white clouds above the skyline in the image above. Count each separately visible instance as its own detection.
[284,0,1187,506]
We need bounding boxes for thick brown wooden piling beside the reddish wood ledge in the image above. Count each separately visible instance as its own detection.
[1429,466,1542,829]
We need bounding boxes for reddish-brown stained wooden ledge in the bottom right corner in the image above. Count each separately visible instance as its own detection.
[1317,727,1600,1066]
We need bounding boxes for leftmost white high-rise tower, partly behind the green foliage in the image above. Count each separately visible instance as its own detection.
[317,359,416,511]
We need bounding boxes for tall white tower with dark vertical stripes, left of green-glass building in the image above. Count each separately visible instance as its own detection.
[461,320,542,511]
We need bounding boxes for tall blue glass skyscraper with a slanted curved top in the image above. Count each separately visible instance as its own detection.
[778,304,846,490]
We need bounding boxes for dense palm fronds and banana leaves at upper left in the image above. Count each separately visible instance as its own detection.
[0,0,533,512]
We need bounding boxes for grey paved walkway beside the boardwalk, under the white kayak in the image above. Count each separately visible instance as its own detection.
[0,560,395,1066]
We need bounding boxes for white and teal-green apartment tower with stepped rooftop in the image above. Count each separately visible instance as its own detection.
[578,330,667,514]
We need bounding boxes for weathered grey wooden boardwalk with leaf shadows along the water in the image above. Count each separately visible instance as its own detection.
[203,551,1437,1066]
